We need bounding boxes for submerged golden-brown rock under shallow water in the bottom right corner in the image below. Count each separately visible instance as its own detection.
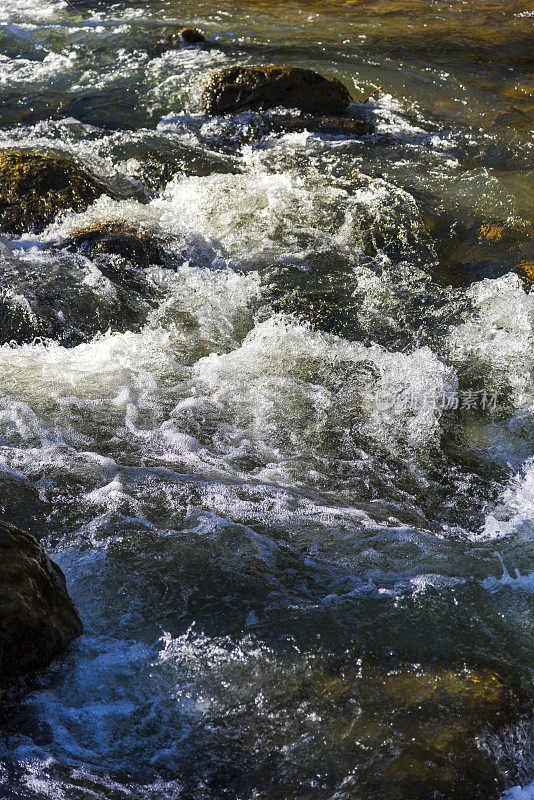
[277,660,533,800]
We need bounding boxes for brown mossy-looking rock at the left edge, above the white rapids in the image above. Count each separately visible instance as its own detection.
[0,150,107,233]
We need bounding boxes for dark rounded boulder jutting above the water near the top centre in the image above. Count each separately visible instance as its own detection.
[202,66,352,115]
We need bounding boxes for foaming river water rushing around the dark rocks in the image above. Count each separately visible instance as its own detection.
[0,0,534,800]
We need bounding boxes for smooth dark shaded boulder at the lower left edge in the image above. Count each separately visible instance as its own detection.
[0,521,82,689]
